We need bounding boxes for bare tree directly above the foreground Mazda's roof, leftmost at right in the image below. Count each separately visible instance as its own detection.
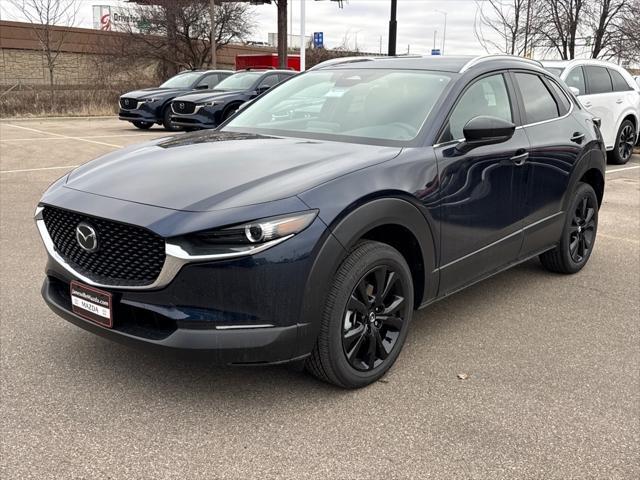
[474,0,537,56]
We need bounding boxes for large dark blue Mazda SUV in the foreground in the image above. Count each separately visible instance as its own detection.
[36,56,605,388]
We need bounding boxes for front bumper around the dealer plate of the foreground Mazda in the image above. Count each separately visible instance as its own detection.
[42,207,335,364]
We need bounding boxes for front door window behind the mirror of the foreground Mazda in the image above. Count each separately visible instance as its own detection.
[440,74,513,142]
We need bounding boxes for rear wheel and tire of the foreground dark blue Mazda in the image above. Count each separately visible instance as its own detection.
[540,183,598,274]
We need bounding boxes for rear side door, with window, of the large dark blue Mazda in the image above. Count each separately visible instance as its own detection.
[512,71,586,257]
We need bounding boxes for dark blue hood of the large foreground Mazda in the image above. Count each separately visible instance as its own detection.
[65,131,401,211]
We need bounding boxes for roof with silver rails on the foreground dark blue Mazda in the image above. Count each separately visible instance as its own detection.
[311,55,542,73]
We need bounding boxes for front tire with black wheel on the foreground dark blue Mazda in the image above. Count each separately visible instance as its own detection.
[306,241,413,388]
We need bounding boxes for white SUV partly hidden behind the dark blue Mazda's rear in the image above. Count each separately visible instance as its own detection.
[542,60,640,164]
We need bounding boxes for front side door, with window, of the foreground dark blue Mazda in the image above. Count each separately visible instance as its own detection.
[434,73,529,294]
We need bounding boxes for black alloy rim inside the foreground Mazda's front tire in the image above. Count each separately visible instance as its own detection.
[342,265,405,371]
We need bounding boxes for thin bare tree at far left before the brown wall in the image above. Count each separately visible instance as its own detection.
[10,0,79,111]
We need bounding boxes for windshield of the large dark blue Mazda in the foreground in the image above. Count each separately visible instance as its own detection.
[224,69,451,144]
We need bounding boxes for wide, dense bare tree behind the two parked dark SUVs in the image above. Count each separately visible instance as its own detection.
[122,0,253,74]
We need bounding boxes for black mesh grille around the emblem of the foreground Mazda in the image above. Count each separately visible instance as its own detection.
[42,207,165,286]
